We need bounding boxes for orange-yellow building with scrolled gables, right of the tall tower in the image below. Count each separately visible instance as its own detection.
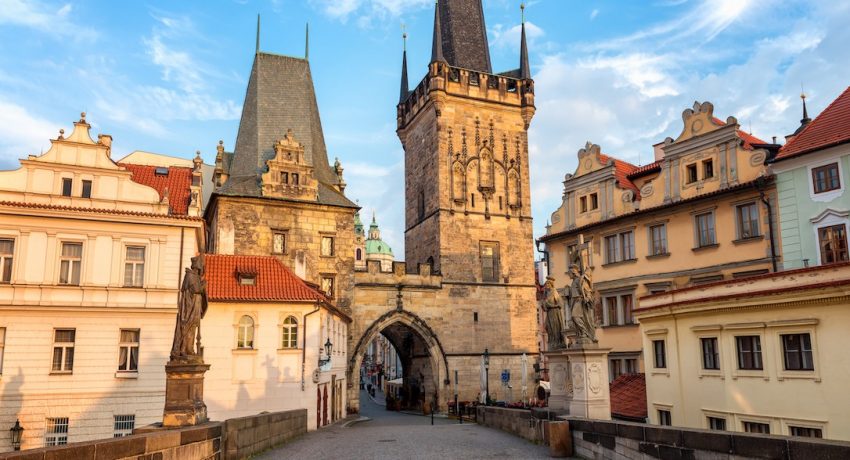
[539,102,778,379]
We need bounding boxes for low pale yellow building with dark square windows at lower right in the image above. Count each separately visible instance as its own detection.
[635,263,850,440]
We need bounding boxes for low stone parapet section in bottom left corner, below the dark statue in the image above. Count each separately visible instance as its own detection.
[0,422,222,460]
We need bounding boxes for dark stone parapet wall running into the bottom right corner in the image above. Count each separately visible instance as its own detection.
[564,417,850,460]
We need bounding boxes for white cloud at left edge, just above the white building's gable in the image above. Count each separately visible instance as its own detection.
[0,99,60,169]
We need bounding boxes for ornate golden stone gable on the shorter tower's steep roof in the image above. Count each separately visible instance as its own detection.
[262,130,319,201]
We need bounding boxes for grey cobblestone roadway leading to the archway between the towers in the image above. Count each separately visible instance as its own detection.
[257,391,549,460]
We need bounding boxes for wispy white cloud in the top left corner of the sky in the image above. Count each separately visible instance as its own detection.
[0,0,97,41]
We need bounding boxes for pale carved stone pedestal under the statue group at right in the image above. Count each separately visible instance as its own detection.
[546,345,611,420]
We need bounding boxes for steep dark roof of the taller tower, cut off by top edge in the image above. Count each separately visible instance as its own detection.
[438,0,493,74]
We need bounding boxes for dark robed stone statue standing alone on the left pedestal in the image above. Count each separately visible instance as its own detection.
[171,254,207,361]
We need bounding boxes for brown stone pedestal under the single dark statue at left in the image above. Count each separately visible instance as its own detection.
[162,361,210,427]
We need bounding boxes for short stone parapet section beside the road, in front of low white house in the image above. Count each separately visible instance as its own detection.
[222,409,307,459]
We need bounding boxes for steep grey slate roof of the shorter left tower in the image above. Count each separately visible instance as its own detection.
[218,52,356,207]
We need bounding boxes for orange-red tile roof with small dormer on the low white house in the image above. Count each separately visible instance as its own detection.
[205,254,328,302]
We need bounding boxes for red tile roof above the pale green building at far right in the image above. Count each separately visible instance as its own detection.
[776,87,850,161]
